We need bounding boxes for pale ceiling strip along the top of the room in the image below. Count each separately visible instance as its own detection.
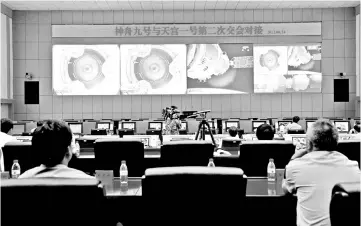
[2,0,360,10]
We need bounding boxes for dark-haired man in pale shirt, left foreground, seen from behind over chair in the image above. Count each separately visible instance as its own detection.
[19,120,93,178]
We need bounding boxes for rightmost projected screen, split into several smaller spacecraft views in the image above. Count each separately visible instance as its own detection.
[253,44,322,93]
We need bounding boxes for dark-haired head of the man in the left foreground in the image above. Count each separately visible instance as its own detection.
[31,120,73,167]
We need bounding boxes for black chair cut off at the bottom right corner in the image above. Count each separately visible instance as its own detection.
[330,181,360,226]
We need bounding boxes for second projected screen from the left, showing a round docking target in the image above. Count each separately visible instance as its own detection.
[120,45,187,95]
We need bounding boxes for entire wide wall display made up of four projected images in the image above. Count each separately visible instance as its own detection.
[53,44,322,95]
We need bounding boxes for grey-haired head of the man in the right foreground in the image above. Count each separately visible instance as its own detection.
[306,119,338,151]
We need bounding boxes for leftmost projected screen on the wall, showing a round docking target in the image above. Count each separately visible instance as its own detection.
[53,45,120,95]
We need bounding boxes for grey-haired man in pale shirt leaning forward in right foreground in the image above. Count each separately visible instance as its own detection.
[282,119,361,226]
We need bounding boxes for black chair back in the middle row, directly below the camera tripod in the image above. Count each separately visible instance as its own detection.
[160,140,214,166]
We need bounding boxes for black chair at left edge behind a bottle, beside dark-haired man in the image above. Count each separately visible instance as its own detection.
[2,141,36,173]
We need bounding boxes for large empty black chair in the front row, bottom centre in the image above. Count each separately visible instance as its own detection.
[142,167,247,226]
